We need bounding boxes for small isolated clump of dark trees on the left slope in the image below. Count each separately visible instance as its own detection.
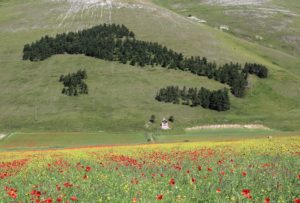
[59,70,88,96]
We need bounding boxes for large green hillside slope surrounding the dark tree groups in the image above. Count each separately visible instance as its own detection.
[0,0,300,132]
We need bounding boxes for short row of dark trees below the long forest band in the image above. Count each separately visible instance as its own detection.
[155,86,230,111]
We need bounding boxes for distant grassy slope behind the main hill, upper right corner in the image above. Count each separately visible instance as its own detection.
[153,0,300,56]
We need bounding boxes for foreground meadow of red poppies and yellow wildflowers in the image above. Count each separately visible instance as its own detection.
[0,136,300,203]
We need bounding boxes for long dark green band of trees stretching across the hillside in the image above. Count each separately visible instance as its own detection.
[23,24,267,97]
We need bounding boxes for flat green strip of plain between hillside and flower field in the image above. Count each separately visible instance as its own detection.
[0,128,298,151]
